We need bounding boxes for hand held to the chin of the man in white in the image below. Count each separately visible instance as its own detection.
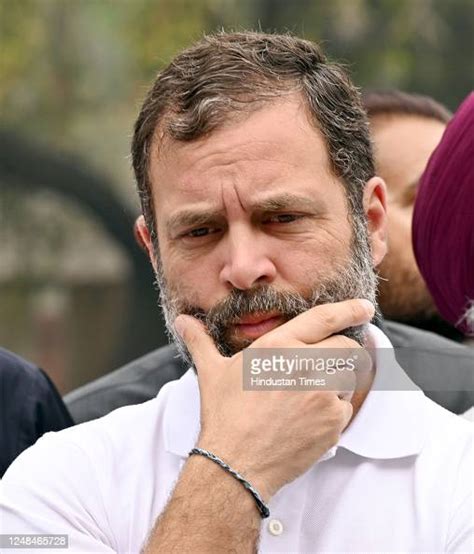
[175,300,374,501]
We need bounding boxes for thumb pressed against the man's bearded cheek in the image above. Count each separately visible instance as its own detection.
[174,315,221,371]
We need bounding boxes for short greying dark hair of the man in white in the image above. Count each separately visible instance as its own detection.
[132,32,375,247]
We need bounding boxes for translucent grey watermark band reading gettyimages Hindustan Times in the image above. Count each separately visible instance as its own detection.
[243,345,474,394]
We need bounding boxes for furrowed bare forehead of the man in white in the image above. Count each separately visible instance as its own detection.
[153,98,332,225]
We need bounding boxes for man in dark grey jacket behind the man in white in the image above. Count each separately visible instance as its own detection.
[65,90,474,423]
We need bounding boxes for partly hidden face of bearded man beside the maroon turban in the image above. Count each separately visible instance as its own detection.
[363,90,462,341]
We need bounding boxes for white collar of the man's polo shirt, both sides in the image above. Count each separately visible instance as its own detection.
[163,325,427,459]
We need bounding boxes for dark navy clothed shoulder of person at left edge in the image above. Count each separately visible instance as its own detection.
[0,348,73,472]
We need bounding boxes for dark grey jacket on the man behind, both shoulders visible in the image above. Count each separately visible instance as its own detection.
[65,321,474,423]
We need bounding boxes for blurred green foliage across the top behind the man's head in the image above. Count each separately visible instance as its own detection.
[0,0,474,171]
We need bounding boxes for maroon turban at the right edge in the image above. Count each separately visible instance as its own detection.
[413,93,474,334]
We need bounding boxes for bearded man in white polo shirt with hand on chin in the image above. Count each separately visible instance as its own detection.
[2,33,472,553]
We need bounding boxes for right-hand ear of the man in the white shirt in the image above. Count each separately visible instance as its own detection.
[363,177,387,267]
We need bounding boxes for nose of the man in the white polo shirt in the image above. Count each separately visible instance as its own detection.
[220,228,277,290]
